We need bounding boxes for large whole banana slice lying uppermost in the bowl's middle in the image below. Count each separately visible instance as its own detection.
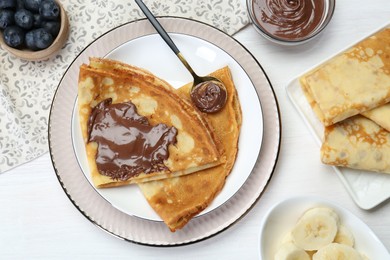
[291,208,339,251]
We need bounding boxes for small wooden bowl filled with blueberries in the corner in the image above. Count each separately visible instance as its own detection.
[0,0,69,61]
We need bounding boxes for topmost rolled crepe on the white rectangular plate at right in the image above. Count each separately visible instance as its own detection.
[300,28,390,126]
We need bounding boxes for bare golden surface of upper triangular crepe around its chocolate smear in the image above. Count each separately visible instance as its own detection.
[78,59,221,188]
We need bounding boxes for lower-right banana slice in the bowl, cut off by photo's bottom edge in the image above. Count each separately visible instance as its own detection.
[313,243,364,260]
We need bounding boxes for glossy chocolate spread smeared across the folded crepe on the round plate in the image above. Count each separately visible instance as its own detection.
[88,99,177,181]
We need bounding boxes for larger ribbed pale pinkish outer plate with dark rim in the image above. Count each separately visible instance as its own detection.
[49,17,281,246]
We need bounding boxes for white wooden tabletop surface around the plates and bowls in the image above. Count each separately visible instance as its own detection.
[0,0,390,259]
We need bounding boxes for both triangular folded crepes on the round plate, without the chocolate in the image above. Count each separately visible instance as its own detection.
[78,58,241,231]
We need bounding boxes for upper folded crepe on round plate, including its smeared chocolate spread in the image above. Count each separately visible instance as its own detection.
[78,59,222,188]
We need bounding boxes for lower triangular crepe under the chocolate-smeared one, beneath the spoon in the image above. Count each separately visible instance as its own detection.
[139,67,241,231]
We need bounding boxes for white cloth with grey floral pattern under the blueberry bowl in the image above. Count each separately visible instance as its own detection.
[0,0,249,173]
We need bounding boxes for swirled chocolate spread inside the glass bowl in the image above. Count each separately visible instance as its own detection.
[252,0,325,40]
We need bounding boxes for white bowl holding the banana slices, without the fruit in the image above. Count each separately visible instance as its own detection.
[259,197,390,259]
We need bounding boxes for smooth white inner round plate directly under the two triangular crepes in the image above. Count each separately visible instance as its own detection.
[72,33,263,221]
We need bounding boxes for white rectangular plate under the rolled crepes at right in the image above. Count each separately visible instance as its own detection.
[287,21,390,209]
